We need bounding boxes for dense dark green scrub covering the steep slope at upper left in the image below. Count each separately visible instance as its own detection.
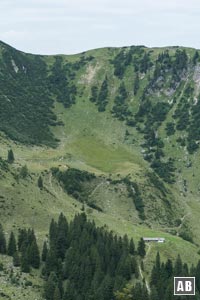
[0,44,56,146]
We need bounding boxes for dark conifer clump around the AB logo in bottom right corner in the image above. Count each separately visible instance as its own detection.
[116,252,200,300]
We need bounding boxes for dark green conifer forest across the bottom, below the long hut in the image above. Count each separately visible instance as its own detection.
[0,213,200,300]
